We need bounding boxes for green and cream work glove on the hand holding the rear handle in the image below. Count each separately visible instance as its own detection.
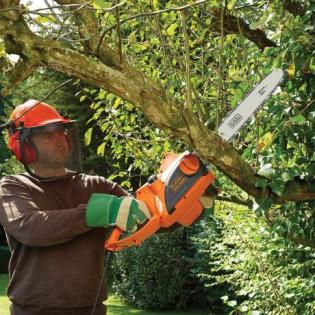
[85,194,151,232]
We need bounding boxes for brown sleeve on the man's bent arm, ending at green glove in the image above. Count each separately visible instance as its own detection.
[0,181,90,246]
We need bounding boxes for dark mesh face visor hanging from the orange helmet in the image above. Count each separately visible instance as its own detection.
[20,121,81,180]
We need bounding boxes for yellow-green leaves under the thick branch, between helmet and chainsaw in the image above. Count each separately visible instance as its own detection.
[81,88,184,189]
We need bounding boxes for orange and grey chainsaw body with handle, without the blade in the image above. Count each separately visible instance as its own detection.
[105,152,214,251]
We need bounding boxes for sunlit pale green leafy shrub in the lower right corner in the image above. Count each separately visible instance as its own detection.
[192,206,315,314]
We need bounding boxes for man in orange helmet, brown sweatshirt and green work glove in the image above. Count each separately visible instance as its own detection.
[0,100,150,315]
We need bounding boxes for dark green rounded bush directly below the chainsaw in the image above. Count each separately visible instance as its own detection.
[111,228,209,310]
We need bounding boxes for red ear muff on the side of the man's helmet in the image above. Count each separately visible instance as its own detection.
[8,131,37,164]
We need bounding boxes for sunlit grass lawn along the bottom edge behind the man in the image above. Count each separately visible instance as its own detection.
[0,274,209,315]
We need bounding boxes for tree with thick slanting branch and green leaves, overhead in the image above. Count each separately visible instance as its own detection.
[0,0,315,245]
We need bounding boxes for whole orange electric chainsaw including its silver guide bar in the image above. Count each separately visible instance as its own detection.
[105,70,283,251]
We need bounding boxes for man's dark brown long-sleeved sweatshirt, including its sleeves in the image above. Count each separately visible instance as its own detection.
[0,174,127,314]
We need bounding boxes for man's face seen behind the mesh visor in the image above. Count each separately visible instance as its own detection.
[32,129,70,166]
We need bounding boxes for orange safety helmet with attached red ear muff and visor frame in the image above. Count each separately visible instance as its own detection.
[8,100,81,180]
